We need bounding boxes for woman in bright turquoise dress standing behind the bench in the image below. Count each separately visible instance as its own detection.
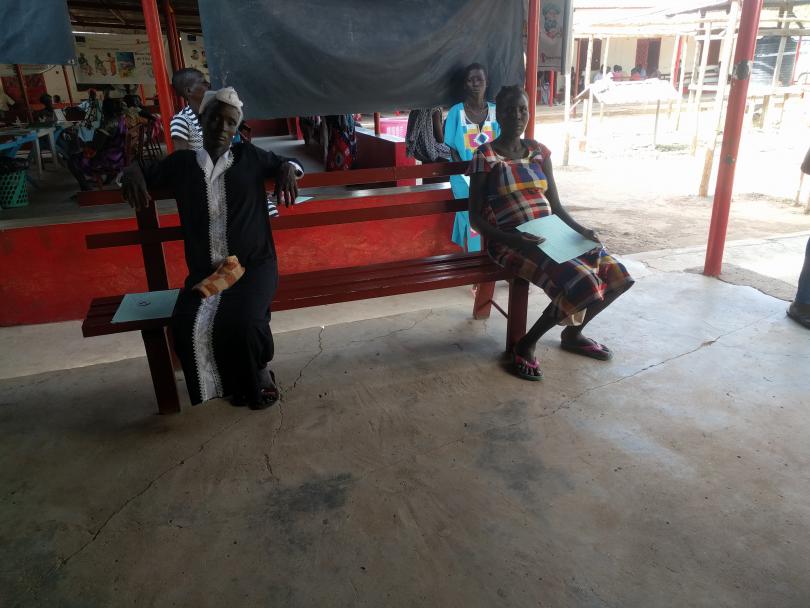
[444,63,501,251]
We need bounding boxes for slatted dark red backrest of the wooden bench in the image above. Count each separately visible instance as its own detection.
[79,162,468,291]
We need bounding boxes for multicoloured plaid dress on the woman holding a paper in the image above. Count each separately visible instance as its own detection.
[467,140,633,321]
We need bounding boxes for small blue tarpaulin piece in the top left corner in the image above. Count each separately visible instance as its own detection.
[0,0,76,65]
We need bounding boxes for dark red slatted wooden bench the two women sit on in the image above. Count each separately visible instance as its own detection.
[79,163,528,413]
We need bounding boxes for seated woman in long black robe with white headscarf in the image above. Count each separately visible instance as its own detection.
[122,87,303,409]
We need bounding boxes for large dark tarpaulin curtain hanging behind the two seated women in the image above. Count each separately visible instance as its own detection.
[199,0,524,118]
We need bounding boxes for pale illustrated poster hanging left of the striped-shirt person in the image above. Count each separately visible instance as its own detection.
[74,34,155,85]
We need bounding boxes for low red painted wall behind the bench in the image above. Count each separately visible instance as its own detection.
[0,214,458,326]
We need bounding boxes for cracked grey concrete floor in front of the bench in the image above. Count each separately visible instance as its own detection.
[0,246,810,608]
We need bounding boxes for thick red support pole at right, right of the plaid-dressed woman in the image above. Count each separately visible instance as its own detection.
[703,0,763,277]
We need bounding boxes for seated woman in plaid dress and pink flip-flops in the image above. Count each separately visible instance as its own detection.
[468,86,633,380]
